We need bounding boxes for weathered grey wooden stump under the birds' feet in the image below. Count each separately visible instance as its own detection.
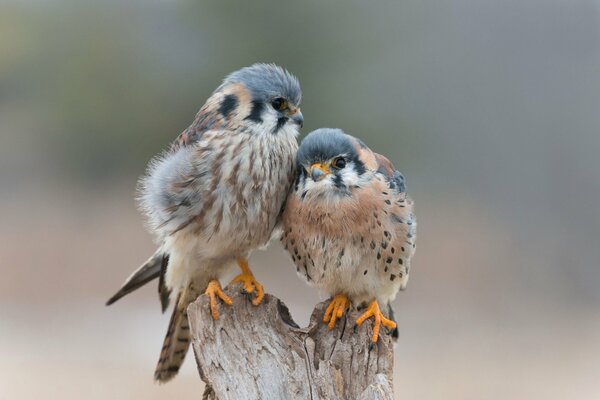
[188,285,393,400]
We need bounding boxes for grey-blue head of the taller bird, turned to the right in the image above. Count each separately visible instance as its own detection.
[217,64,304,136]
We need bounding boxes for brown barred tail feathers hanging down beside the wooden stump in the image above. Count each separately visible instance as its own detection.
[154,284,200,383]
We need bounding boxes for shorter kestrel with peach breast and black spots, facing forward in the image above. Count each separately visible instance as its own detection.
[281,128,416,342]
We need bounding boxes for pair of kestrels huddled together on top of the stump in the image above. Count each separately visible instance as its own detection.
[107,64,416,382]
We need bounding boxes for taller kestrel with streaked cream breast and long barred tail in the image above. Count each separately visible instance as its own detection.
[107,63,304,383]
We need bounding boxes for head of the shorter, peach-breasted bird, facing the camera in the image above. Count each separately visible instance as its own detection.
[296,128,367,198]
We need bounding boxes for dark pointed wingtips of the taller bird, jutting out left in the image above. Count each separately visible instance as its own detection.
[106,248,169,311]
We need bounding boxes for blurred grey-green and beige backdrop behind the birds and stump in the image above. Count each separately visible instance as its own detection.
[0,0,600,400]
